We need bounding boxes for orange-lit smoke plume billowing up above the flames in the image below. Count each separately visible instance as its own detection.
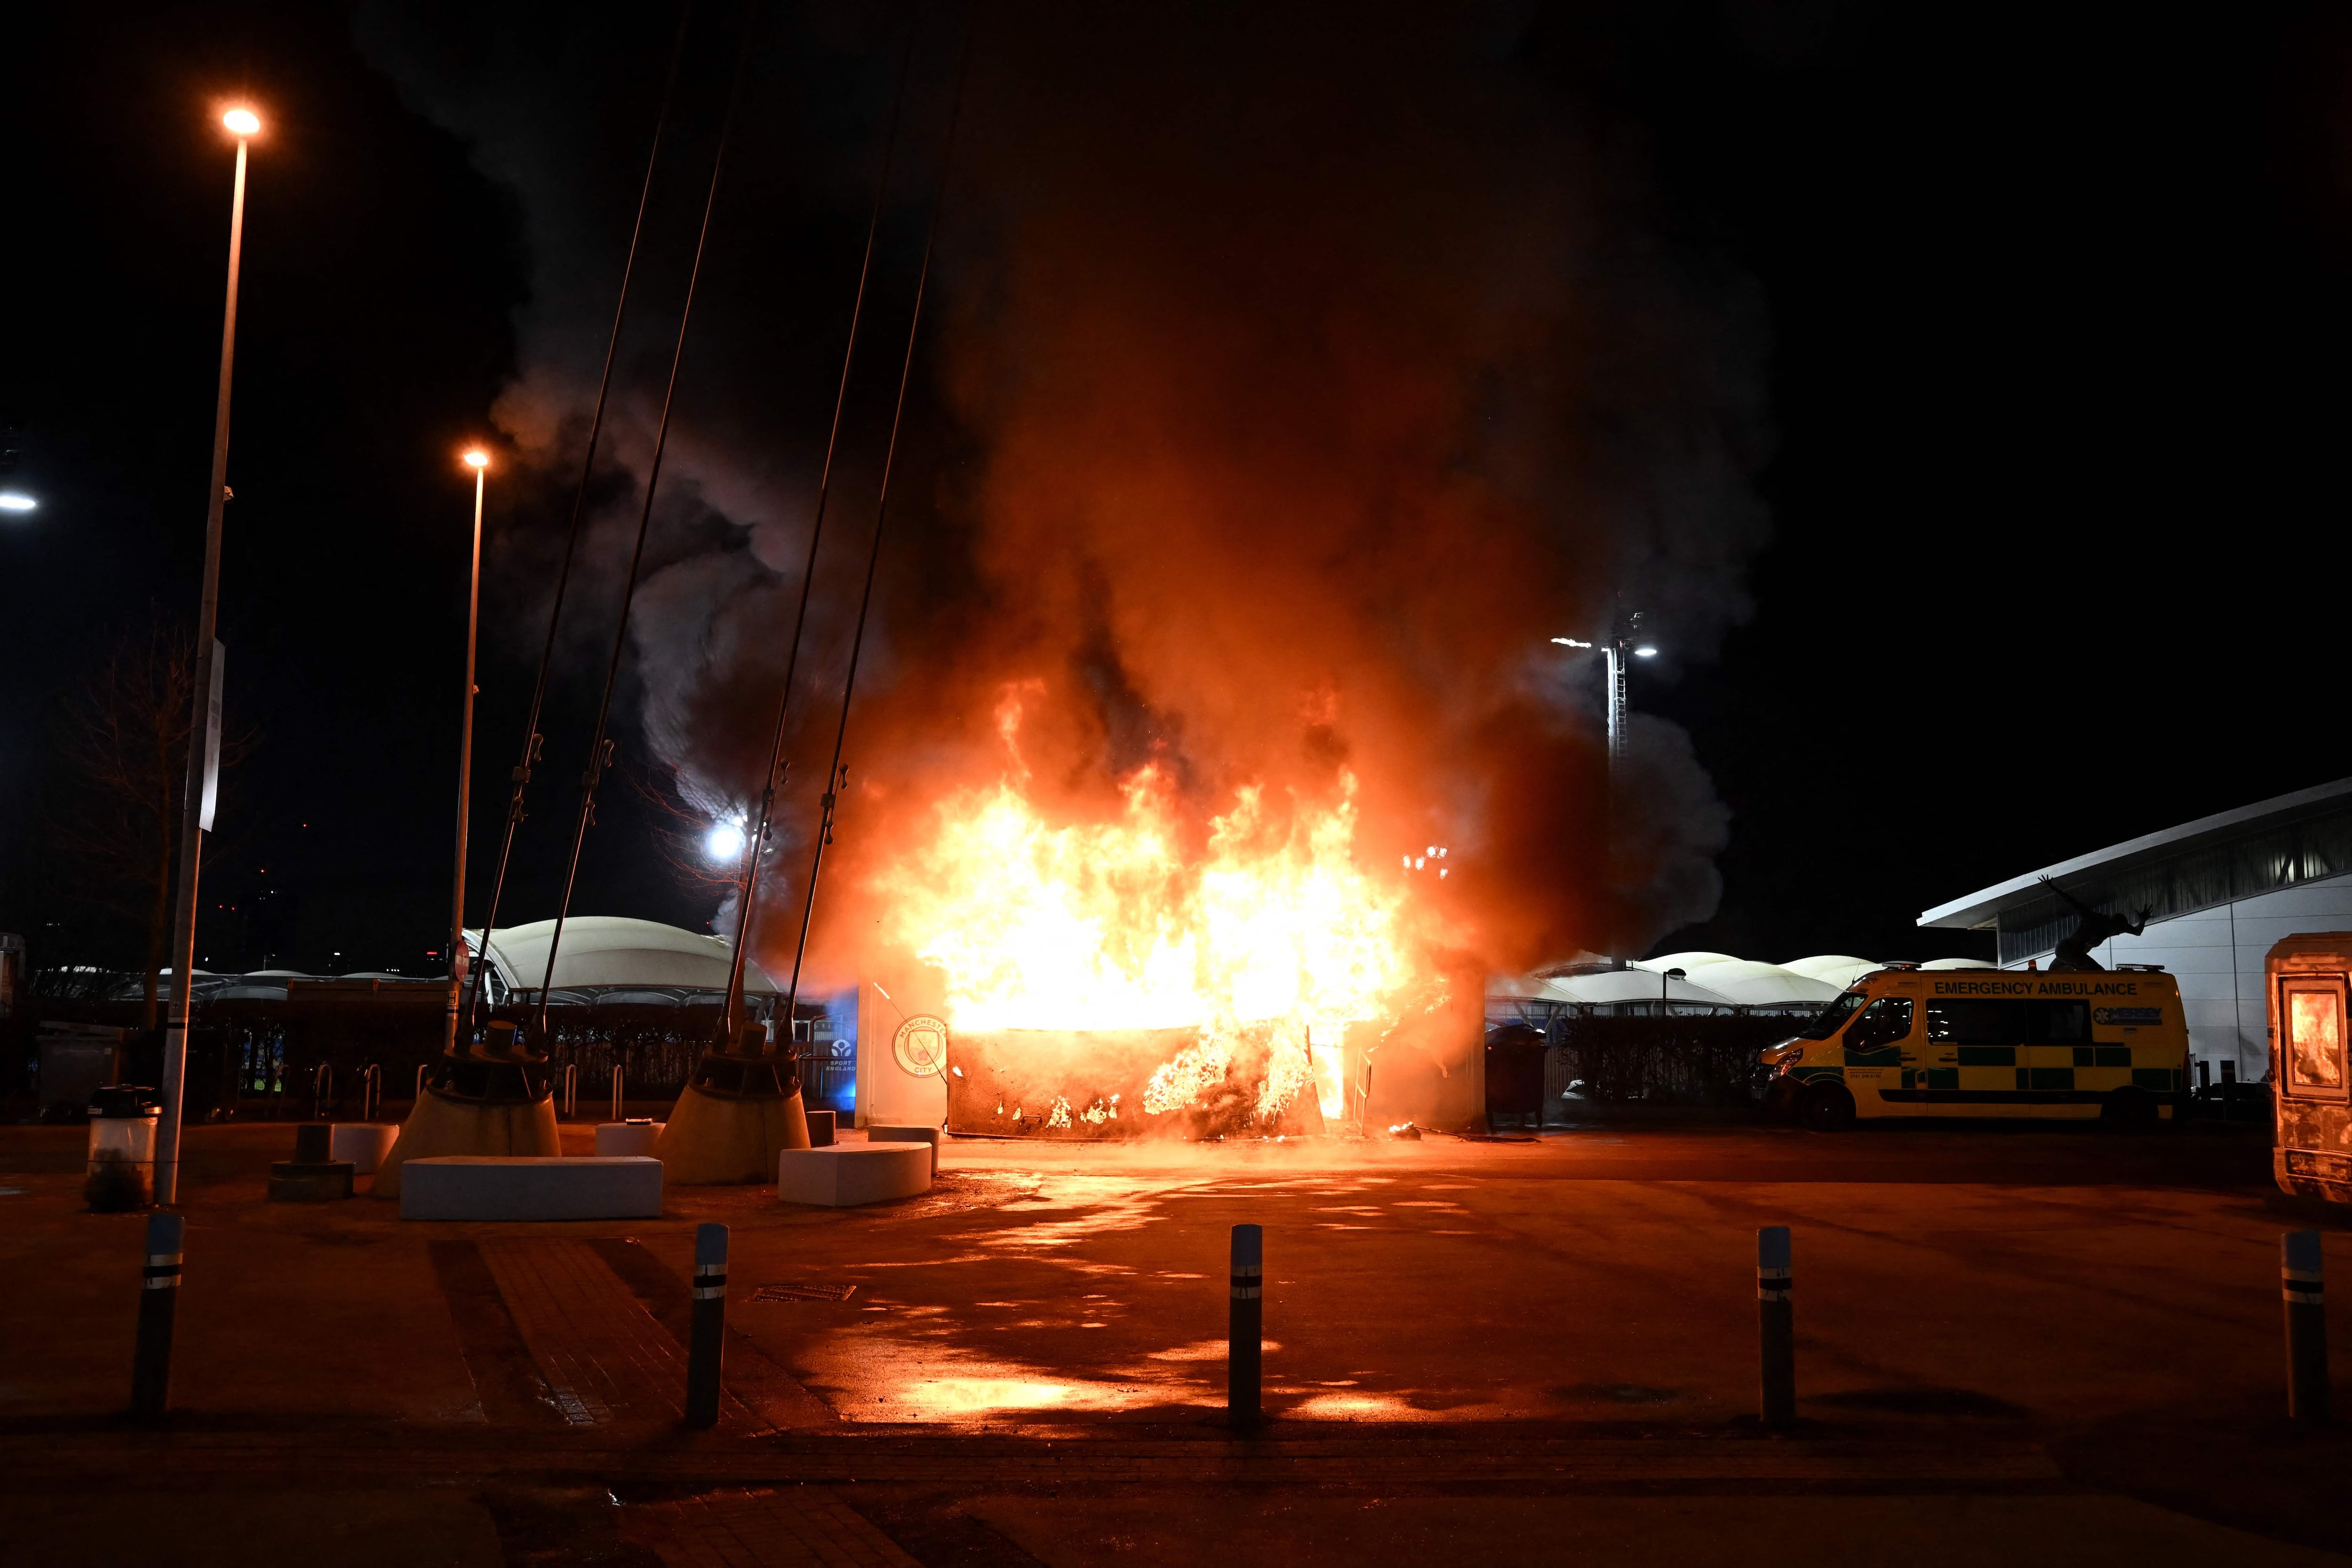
[362,0,1764,973]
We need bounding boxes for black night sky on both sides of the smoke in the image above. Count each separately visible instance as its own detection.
[0,0,2352,973]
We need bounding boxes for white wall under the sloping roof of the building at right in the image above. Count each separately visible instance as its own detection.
[2013,877,2352,1079]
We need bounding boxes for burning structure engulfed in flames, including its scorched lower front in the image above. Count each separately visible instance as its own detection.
[866,700,1477,1140]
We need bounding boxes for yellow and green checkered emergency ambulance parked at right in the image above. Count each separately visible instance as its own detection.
[1764,964,2190,1133]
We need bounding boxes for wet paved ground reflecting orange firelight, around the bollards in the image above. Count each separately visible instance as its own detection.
[0,1124,2352,1568]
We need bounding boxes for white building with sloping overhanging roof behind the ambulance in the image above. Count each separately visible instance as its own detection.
[1919,778,2352,1079]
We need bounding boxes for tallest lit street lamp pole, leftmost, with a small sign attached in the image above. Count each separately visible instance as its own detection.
[155,103,261,1204]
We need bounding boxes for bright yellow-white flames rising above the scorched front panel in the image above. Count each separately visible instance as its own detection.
[877,717,1416,1117]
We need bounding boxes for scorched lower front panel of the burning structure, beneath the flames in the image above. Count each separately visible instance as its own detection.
[948,1020,1345,1142]
